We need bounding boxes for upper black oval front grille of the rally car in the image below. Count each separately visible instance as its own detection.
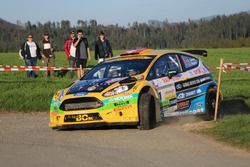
[60,97,103,111]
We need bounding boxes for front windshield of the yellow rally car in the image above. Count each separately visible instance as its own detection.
[81,58,152,80]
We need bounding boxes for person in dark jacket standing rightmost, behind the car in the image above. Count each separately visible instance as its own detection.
[95,31,113,62]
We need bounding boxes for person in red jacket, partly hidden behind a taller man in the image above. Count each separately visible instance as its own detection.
[64,31,76,78]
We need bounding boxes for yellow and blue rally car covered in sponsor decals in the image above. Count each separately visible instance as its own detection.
[49,49,217,130]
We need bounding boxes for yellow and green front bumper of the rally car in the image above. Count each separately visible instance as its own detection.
[49,94,139,128]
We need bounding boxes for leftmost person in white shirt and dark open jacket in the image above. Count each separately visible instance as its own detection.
[21,34,41,78]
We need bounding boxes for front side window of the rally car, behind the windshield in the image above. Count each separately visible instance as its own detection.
[147,54,181,80]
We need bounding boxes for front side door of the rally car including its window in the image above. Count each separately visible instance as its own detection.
[147,54,181,117]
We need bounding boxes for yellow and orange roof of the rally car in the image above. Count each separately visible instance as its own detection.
[106,49,195,62]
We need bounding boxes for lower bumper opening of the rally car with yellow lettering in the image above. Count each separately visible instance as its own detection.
[64,113,102,122]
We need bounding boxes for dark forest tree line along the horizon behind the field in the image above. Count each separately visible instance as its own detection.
[0,12,250,52]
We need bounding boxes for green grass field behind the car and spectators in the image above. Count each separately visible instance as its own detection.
[0,48,250,112]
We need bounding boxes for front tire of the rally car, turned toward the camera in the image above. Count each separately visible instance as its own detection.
[138,93,156,130]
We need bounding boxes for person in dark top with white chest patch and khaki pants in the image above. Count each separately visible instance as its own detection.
[39,32,55,77]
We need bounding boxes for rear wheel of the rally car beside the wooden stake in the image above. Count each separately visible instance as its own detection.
[205,88,220,121]
